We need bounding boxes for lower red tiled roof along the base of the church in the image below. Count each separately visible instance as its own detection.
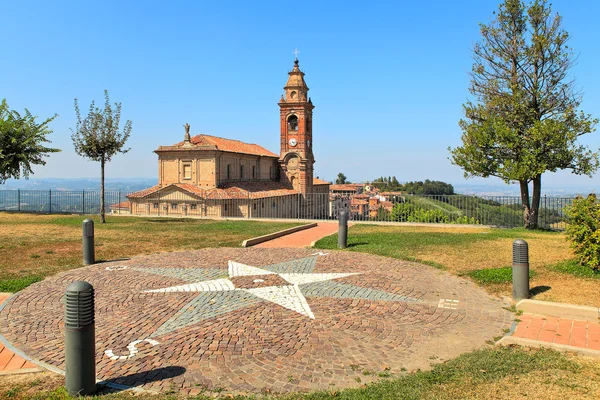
[127,181,298,200]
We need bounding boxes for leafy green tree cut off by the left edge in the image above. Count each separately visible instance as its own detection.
[0,99,60,183]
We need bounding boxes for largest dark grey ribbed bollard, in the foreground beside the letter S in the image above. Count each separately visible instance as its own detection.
[65,281,96,396]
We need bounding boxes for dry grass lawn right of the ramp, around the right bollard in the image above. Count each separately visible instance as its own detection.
[316,224,600,307]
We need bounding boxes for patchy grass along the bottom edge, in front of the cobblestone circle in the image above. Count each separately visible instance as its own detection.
[0,347,600,400]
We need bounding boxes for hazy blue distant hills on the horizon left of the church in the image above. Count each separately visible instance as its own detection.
[0,178,158,192]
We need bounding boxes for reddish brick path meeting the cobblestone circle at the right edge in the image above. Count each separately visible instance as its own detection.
[513,314,600,350]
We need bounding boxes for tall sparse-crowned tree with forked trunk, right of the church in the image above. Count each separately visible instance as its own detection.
[448,0,598,229]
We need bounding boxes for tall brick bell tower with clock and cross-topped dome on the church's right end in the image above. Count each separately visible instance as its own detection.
[279,58,315,194]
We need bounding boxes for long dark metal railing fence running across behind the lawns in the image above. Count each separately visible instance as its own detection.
[0,190,573,229]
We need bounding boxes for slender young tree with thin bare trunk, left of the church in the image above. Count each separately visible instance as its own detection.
[71,90,131,223]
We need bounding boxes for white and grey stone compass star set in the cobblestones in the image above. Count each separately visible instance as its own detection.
[134,256,419,337]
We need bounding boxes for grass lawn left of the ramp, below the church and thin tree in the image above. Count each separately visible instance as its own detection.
[0,212,299,292]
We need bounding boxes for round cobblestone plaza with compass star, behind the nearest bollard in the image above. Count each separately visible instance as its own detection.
[0,248,513,394]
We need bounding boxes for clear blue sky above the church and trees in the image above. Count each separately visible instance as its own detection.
[0,0,600,187]
